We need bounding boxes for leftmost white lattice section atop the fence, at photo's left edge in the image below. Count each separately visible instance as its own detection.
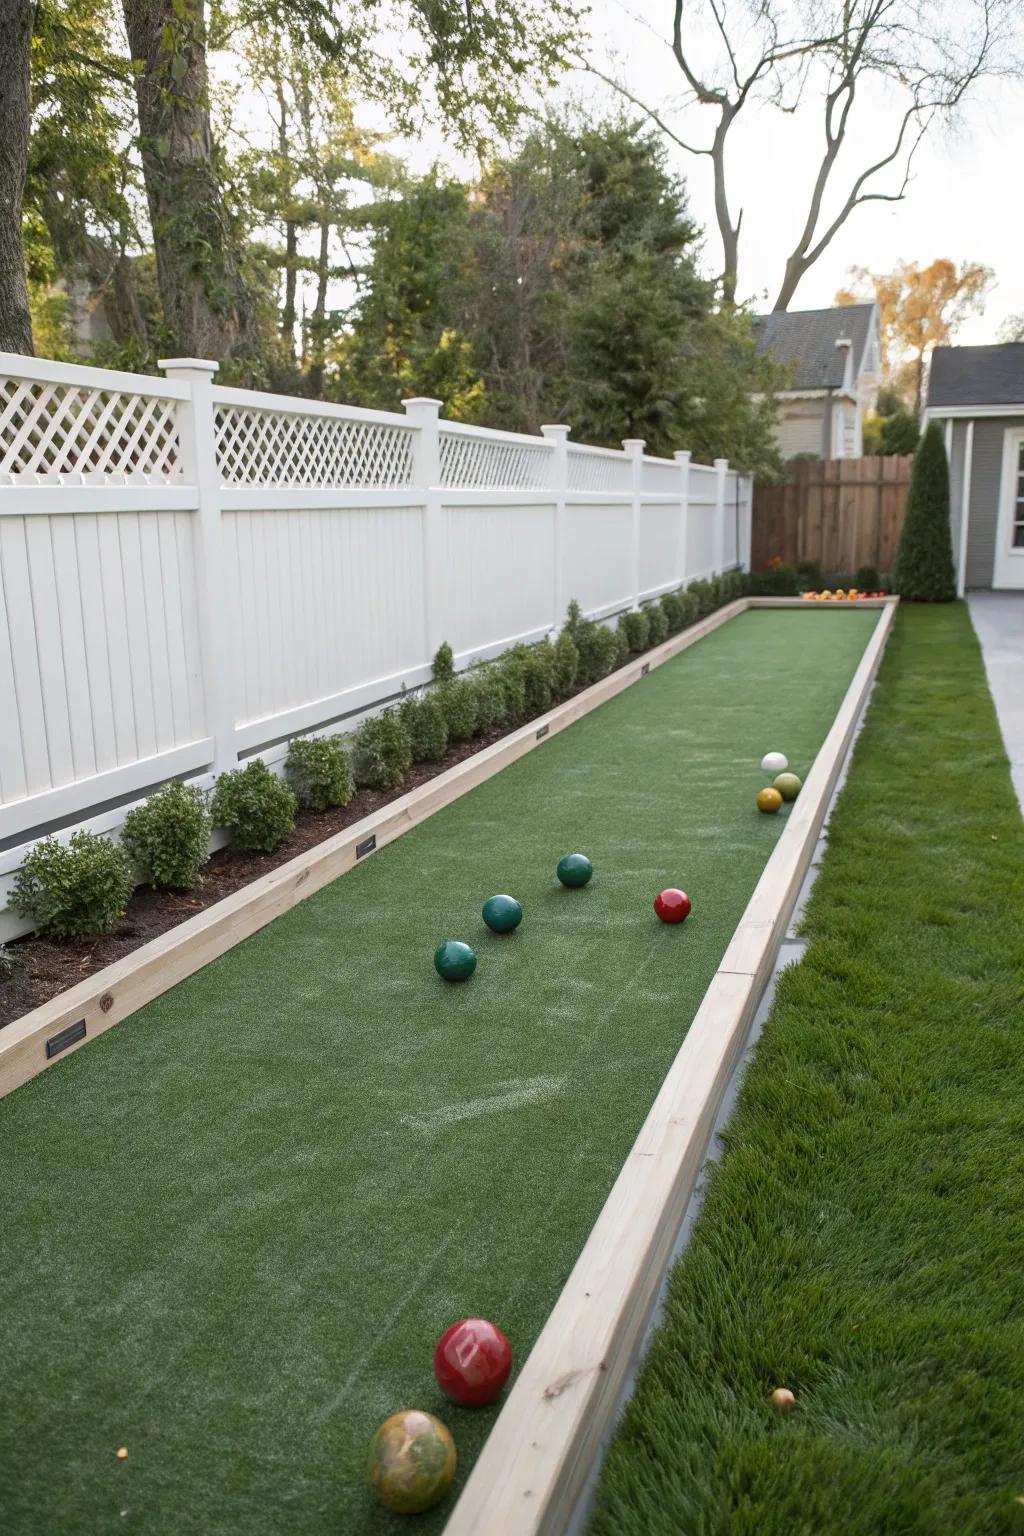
[0,376,181,484]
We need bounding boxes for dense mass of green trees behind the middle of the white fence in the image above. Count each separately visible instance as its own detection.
[333,118,778,472]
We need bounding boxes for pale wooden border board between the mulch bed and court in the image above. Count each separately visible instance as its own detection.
[0,598,776,1098]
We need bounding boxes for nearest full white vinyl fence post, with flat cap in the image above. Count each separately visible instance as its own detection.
[158,358,238,774]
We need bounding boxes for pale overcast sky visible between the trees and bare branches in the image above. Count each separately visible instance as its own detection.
[373,0,1024,343]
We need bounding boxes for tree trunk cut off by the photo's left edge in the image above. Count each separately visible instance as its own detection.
[0,0,35,355]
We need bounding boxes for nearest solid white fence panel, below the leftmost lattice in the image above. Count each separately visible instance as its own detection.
[0,510,206,828]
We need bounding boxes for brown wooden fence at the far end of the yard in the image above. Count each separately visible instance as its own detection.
[751,453,913,571]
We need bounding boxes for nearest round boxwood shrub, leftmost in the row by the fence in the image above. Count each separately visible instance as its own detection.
[11,829,135,940]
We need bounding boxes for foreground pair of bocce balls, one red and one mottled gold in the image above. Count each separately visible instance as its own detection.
[370,1318,511,1514]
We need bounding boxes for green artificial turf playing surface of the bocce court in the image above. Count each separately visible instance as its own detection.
[0,611,877,1536]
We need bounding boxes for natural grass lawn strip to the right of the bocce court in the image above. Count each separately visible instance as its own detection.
[590,604,1024,1536]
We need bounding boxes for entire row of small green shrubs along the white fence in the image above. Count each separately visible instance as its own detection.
[11,571,745,940]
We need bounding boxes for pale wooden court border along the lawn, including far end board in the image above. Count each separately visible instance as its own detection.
[445,599,898,1536]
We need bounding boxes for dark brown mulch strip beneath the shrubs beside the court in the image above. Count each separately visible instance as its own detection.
[0,727,507,1028]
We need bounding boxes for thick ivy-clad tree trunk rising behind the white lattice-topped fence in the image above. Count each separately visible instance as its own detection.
[121,0,259,361]
